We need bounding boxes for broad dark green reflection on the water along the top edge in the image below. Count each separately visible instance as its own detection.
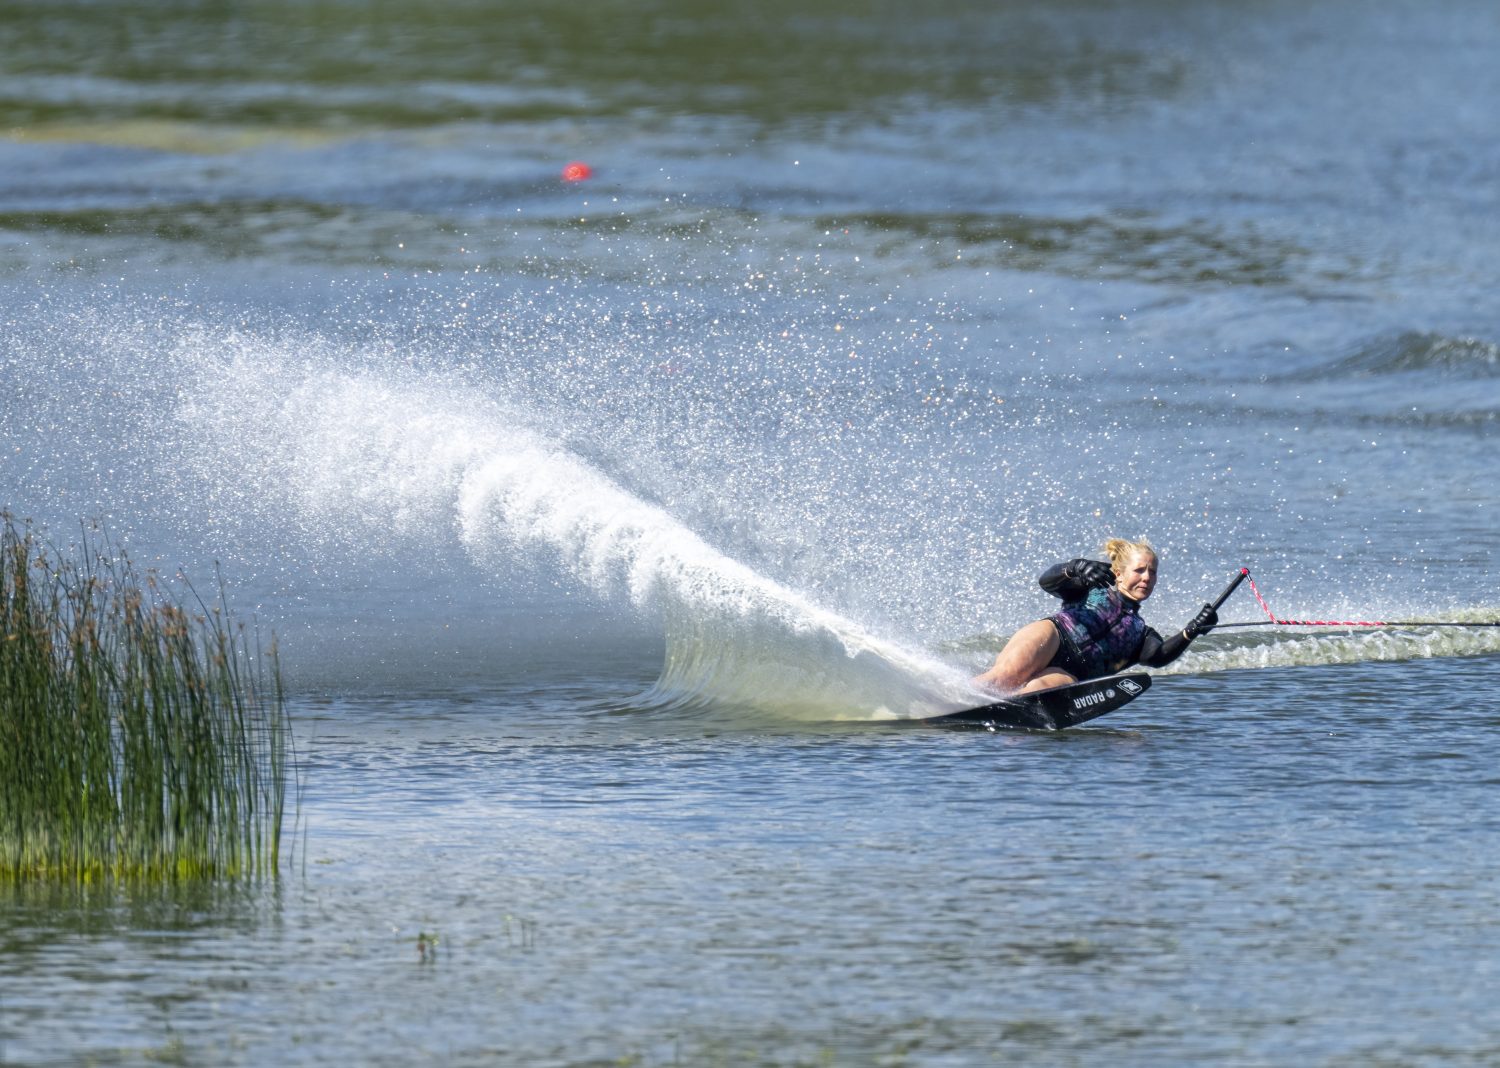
[0,0,1187,135]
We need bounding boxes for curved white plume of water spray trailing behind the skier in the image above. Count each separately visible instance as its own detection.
[170,333,974,719]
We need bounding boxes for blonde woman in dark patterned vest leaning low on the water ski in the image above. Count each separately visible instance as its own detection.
[974,539,1218,693]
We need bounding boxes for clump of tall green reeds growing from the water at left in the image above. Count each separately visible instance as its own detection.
[0,513,291,881]
